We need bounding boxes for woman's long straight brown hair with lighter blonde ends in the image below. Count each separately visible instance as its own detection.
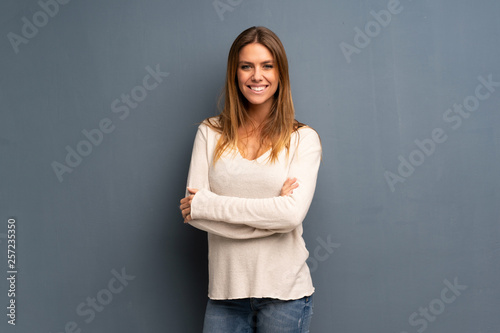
[207,27,304,163]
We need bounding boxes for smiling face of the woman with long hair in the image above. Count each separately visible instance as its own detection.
[237,43,278,108]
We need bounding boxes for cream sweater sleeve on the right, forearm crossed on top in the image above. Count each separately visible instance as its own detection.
[191,128,321,233]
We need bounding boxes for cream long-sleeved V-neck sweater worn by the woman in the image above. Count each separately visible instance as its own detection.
[186,118,321,300]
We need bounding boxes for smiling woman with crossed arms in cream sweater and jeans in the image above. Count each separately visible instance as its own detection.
[180,27,321,333]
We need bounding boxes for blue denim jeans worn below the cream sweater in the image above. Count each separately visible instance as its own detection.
[203,295,313,333]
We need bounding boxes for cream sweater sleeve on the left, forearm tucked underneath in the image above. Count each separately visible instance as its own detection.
[186,124,275,239]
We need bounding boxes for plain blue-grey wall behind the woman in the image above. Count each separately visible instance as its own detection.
[0,0,500,333]
